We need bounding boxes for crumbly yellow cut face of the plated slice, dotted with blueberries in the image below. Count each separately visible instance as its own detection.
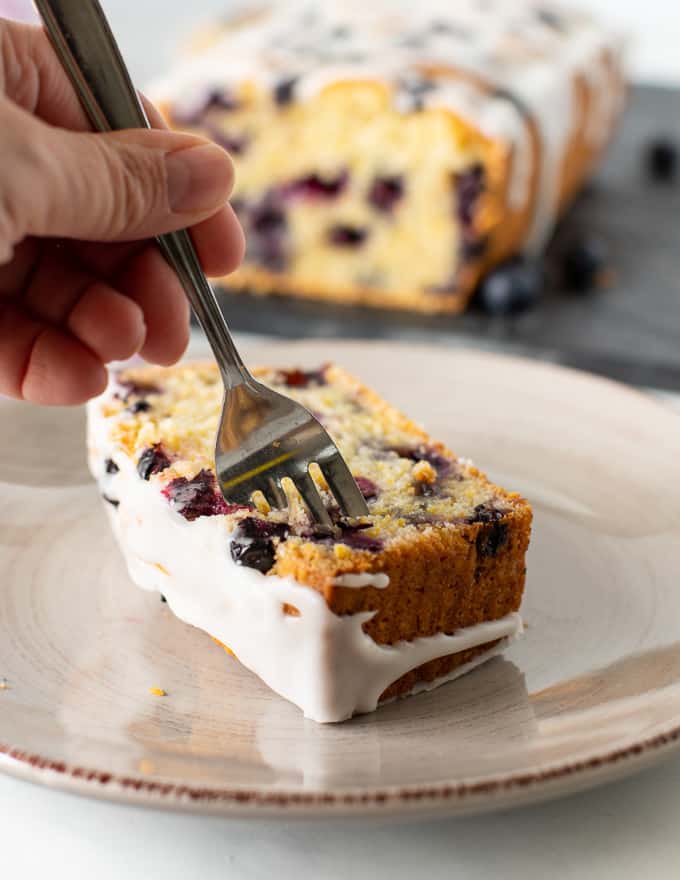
[95,364,514,556]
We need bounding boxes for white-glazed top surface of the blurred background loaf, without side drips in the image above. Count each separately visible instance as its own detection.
[154,0,615,110]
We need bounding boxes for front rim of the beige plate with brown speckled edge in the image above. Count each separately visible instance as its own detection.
[0,722,680,819]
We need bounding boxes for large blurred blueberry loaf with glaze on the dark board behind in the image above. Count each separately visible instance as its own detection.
[154,0,624,312]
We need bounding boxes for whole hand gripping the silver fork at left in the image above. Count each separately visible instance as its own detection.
[0,18,243,404]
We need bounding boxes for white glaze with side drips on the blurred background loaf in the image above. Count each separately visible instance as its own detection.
[153,0,623,252]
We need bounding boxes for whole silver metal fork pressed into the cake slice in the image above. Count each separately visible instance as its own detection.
[35,0,368,529]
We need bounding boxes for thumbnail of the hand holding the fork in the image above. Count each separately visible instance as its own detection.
[165,144,233,214]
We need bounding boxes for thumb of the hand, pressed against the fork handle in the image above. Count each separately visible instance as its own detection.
[0,100,233,251]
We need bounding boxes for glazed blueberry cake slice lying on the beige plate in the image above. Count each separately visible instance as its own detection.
[88,364,531,722]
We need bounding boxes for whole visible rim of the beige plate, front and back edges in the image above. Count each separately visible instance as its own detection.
[0,337,680,820]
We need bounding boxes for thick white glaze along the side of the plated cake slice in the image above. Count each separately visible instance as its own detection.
[88,389,521,722]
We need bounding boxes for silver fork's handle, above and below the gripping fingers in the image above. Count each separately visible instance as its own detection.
[34,0,250,389]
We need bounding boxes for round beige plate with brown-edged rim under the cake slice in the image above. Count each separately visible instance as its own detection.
[0,342,680,817]
